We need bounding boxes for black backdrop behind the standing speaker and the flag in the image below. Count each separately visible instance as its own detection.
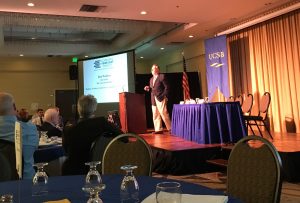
[135,72,202,128]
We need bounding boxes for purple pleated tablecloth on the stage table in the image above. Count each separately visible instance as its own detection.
[172,102,247,144]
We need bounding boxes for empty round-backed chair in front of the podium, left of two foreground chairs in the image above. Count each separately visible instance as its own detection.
[102,133,152,176]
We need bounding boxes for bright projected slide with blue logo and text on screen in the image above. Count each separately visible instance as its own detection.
[83,53,128,103]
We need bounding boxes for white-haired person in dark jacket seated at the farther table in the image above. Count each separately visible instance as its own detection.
[40,108,62,137]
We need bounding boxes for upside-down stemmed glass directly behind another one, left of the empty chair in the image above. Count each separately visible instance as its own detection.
[85,161,102,186]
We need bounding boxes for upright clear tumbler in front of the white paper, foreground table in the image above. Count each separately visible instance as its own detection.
[156,182,181,203]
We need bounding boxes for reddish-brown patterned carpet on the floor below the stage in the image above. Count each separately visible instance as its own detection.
[153,172,300,203]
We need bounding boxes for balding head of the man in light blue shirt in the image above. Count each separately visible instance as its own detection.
[0,92,15,116]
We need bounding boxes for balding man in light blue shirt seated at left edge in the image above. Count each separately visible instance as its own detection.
[0,92,38,179]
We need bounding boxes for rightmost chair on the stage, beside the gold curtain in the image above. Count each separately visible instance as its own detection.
[244,92,273,139]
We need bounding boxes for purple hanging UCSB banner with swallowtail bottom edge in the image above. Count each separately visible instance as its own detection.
[205,35,229,98]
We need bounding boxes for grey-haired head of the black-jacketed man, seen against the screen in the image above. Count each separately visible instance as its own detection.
[77,95,97,118]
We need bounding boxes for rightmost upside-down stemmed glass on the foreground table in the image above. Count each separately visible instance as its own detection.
[120,165,139,203]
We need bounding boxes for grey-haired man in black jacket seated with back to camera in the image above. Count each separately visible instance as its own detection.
[62,95,122,175]
